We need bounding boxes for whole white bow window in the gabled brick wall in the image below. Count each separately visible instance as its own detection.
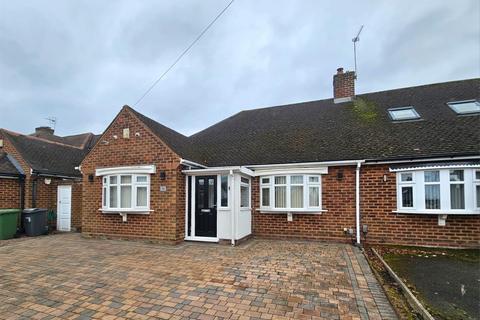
[102,174,150,211]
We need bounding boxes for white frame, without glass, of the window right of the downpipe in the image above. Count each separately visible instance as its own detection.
[393,167,480,215]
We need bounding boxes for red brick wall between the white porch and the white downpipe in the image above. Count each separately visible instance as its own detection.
[252,167,355,242]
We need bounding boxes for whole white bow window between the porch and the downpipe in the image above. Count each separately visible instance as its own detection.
[260,174,321,211]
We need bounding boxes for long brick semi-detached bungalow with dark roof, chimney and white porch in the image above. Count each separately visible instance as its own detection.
[80,68,480,247]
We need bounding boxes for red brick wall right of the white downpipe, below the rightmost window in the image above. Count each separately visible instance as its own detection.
[361,165,480,247]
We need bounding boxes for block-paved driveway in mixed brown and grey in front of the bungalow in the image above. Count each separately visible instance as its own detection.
[0,234,396,319]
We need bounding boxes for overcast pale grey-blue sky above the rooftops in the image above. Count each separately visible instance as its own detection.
[0,0,480,135]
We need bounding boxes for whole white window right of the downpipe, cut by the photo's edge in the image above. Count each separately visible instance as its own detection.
[397,168,480,214]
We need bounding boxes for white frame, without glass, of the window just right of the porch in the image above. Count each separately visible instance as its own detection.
[260,173,324,213]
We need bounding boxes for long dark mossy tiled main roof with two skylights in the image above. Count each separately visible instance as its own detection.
[189,79,480,166]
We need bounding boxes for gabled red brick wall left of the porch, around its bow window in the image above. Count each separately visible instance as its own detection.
[82,109,185,242]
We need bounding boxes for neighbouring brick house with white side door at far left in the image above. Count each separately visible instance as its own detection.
[0,127,98,231]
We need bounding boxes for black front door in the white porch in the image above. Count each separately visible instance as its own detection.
[195,176,217,238]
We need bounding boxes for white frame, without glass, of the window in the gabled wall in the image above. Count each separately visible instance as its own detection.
[101,173,151,213]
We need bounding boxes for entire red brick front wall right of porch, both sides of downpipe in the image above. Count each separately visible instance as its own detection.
[252,165,480,247]
